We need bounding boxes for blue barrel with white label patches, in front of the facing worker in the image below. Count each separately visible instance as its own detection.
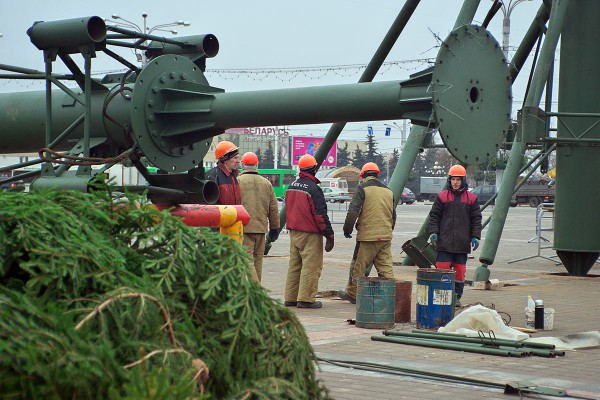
[417,268,454,329]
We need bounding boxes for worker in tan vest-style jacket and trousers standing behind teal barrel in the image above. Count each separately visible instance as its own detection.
[338,162,396,304]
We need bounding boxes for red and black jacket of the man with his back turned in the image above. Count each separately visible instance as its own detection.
[285,172,333,238]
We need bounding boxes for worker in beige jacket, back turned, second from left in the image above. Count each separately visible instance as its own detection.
[238,152,279,282]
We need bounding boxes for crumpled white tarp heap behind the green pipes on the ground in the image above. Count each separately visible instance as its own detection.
[438,305,529,340]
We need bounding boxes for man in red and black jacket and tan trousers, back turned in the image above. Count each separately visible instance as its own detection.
[284,154,334,308]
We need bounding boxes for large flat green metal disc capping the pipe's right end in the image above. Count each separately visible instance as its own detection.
[431,25,512,164]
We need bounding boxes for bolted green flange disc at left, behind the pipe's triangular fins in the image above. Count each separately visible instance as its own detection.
[131,55,211,172]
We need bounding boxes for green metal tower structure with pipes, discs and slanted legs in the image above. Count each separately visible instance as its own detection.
[0,0,600,280]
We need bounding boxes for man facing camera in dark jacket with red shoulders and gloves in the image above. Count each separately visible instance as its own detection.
[429,165,482,307]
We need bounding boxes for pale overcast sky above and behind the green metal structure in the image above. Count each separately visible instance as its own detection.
[0,0,542,150]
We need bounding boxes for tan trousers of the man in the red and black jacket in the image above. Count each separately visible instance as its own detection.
[284,230,323,303]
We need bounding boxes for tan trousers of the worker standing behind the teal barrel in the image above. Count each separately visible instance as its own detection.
[346,240,394,299]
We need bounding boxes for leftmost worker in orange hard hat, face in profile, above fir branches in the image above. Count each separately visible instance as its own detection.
[206,140,242,205]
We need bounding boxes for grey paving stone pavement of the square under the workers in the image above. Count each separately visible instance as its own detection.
[262,203,600,400]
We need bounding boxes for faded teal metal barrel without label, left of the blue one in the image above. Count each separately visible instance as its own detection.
[356,277,396,329]
